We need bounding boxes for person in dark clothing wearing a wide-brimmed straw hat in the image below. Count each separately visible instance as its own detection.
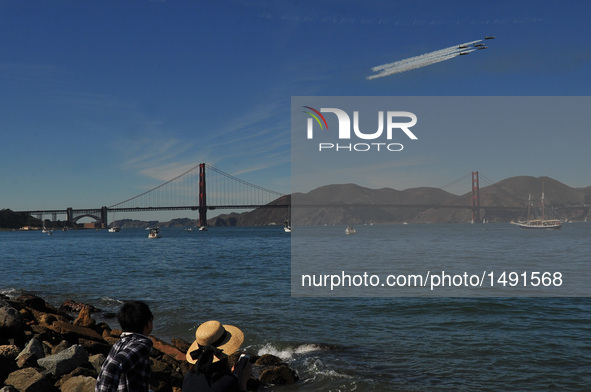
[182,320,252,392]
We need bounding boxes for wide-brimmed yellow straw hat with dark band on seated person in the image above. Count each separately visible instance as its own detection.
[186,320,244,363]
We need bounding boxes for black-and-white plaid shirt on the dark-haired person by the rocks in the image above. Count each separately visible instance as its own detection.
[95,333,152,392]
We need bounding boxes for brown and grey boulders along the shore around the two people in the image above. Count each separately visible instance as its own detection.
[0,294,298,392]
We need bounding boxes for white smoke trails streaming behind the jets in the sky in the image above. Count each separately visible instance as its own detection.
[367,39,482,80]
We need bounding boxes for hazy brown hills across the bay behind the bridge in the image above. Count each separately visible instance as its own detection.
[114,176,591,227]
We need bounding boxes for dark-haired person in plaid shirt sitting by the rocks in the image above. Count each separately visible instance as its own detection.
[95,301,154,392]
